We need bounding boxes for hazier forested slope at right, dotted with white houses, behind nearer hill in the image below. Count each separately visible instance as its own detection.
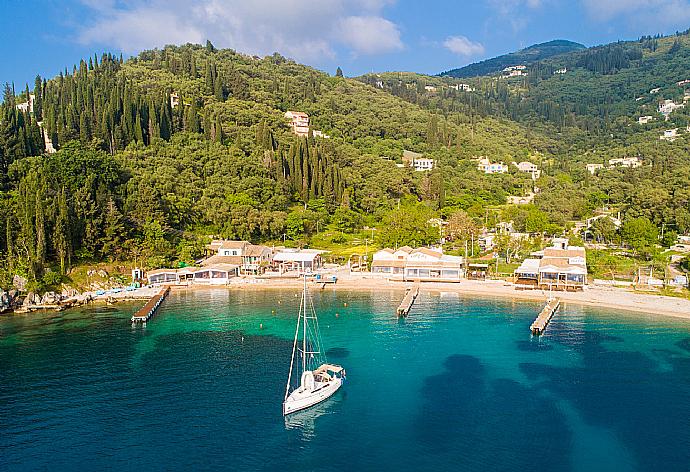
[360,31,690,138]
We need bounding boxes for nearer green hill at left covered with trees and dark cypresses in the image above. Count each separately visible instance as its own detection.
[0,43,555,287]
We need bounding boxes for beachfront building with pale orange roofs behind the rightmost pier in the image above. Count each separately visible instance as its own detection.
[514,238,587,291]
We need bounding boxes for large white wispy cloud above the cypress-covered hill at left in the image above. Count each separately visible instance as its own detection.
[78,0,403,61]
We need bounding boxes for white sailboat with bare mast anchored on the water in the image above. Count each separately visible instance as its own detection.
[283,277,345,415]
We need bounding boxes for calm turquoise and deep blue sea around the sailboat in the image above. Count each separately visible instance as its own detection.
[0,289,690,471]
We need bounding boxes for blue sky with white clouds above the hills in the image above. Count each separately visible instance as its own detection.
[0,0,690,89]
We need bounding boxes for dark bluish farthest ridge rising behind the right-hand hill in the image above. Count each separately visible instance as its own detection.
[440,39,586,78]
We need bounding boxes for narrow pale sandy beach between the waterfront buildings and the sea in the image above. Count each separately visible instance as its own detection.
[171,275,690,321]
